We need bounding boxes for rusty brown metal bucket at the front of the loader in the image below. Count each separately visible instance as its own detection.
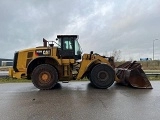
[116,61,152,88]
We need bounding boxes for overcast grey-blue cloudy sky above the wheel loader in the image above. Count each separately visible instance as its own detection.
[0,0,160,61]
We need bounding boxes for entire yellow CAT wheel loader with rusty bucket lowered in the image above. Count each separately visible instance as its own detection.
[9,35,152,90]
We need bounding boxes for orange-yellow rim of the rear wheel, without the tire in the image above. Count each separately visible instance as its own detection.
[39,71,51,83]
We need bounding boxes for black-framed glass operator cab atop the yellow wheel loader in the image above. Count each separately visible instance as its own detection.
[56,35,82,60]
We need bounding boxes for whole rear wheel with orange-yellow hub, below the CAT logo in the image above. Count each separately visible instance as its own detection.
[31,64,58,90]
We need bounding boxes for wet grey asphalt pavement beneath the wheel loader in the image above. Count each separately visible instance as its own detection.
[0,81,160,120]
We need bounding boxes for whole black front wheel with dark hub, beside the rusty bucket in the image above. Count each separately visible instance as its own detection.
[90,64,115,89]
